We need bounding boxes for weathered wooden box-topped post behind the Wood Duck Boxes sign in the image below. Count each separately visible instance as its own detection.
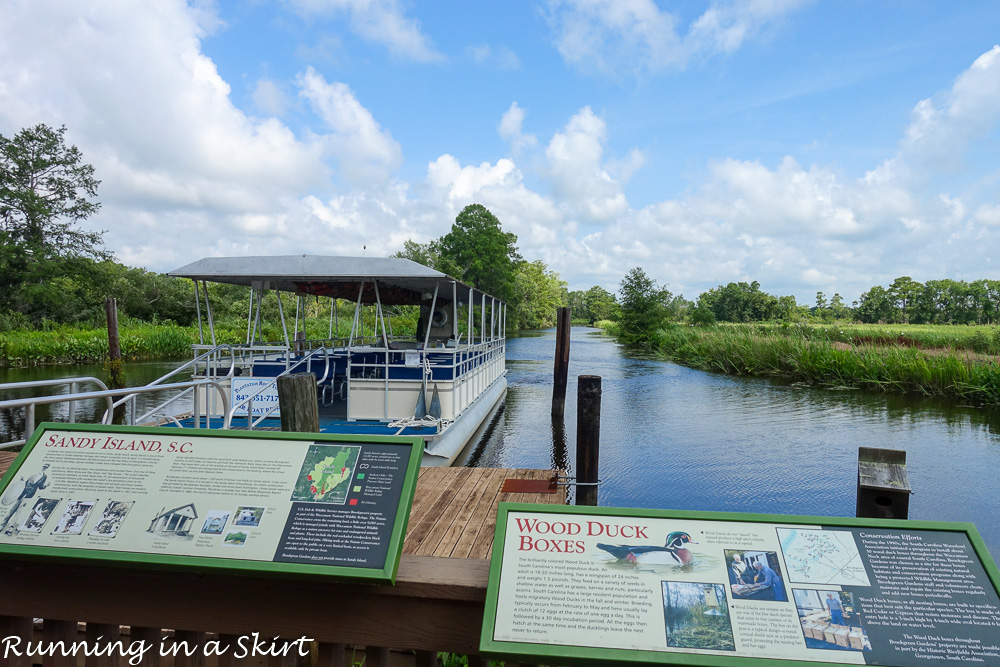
[855,447,910,519]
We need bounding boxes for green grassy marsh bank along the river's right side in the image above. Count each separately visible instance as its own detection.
[606,324,1000,404]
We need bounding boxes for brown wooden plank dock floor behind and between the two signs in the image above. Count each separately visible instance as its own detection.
[0,452,566,559]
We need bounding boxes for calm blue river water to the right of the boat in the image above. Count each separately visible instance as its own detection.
[458,328,1000,555]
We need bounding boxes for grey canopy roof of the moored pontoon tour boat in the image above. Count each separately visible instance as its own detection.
[173,255,504,305]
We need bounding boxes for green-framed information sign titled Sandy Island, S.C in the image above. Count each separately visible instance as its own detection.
[0,424,423,582]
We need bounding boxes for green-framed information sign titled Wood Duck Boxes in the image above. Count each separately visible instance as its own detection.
[480,503,1000,667]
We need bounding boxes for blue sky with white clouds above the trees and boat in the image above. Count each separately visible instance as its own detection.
[0,0,1000,305]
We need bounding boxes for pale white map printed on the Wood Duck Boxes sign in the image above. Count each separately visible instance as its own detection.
[778,528,870,586]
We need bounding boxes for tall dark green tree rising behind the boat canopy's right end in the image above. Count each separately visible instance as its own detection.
[439,204,521,303]
